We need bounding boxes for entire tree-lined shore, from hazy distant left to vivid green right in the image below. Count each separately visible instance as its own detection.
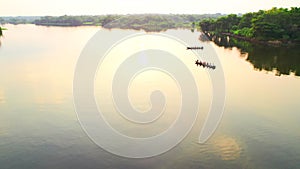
[0,7,300,46]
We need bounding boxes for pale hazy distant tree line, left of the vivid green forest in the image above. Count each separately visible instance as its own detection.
[0,13,225,32]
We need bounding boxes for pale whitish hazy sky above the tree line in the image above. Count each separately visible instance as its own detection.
[0,0,300,16]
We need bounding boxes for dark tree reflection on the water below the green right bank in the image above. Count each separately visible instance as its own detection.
[199,34,300,76]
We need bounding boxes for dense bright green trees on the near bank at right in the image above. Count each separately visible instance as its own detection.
[199,7,300,42]
